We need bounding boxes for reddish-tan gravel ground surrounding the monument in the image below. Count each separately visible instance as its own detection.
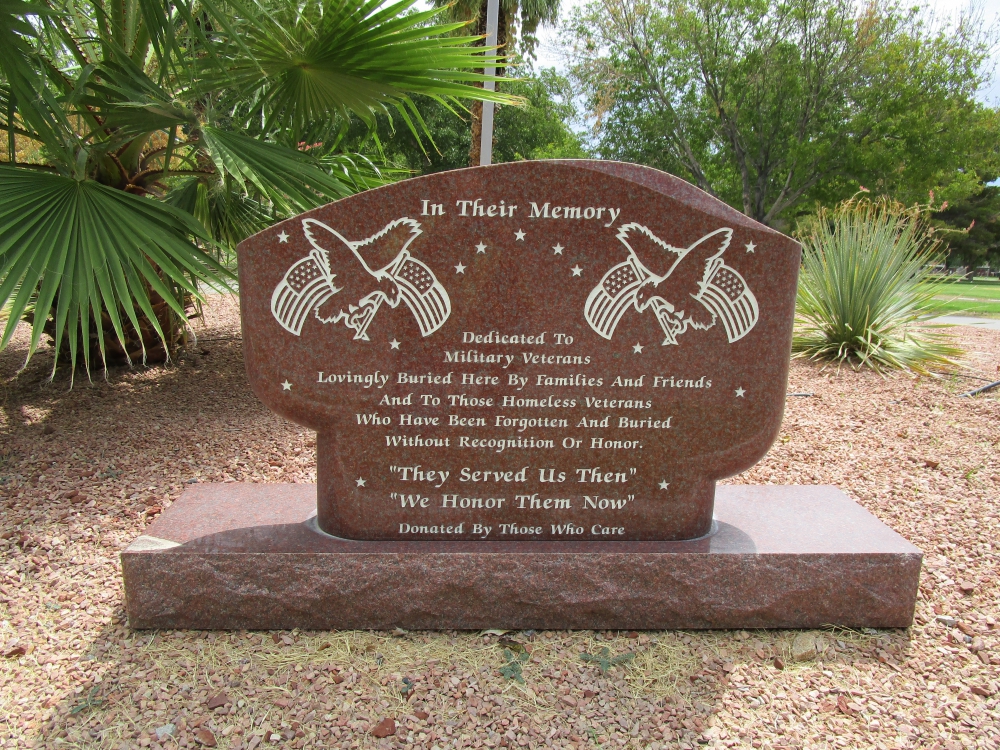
[0,298,1000,750]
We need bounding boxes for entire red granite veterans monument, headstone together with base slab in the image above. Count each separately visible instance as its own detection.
[123,161,920,628]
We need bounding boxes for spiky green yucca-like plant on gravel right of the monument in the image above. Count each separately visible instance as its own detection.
[792,197,961,373]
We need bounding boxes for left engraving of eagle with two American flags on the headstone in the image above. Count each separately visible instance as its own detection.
[271,218,451,341]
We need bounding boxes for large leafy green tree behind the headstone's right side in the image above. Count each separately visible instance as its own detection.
[571,0,1000,226]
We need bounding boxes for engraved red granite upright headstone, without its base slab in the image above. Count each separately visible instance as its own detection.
[232,161,799,541]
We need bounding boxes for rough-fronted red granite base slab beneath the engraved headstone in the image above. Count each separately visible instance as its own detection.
[122,483,922,630]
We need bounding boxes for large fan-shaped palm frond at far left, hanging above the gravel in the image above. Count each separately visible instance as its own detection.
[0,165,233,373]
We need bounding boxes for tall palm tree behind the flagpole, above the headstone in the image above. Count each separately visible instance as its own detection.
[433,0,559,167]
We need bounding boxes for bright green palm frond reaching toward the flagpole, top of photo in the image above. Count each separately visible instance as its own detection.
[217,0,517,134]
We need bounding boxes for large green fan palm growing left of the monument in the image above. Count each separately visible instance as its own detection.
[0,0,511,376]
